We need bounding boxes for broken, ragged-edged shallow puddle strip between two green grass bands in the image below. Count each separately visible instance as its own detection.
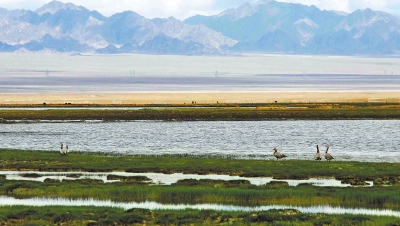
[0,171,373,187]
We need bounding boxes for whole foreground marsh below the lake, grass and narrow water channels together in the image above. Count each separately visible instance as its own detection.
[0,150,400,225]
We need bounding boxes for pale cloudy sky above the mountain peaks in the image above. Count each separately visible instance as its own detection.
[0,0,400,19]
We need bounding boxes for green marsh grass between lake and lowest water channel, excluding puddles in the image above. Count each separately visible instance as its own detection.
[0,150,400,210]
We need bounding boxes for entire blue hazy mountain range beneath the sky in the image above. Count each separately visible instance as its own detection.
[0,0,400,55]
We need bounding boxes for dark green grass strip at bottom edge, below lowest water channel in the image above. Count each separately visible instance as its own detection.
[0,207,400,226]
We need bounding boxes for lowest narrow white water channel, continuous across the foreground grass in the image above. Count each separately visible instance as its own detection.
[0,196,400,217]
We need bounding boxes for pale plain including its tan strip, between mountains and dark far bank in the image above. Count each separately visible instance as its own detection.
[0,54,400,105]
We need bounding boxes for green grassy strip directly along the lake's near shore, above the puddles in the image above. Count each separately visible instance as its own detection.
[0,149,400,180]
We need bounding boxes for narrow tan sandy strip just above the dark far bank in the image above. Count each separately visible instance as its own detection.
[0,91,400,106]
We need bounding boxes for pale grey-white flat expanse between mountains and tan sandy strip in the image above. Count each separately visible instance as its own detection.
[0,53,400,94]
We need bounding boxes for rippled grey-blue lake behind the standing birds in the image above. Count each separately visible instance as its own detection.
[0,120,400,162]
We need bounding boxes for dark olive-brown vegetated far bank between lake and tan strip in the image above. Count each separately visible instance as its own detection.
[0,103,400,123]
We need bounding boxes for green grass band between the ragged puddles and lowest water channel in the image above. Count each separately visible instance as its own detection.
[0,178,400,210]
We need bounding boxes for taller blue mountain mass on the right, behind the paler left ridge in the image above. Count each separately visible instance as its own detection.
[184,0,400,55]
